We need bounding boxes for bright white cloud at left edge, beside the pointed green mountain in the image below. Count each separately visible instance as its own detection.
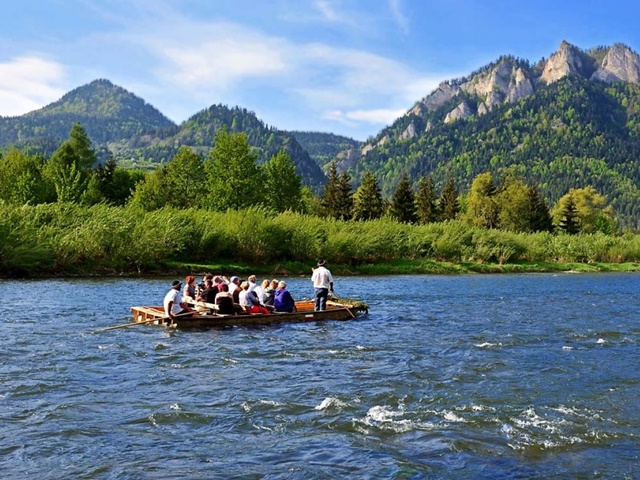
[0,56,65,116]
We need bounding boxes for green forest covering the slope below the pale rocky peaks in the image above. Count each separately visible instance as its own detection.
[350,76,640,229]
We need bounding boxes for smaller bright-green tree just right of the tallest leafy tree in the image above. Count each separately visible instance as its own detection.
[263,150,302,212]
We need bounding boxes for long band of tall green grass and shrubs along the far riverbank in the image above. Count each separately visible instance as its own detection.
[0,204,640,275]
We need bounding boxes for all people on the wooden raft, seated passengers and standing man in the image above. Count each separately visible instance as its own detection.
[164,260,333,320]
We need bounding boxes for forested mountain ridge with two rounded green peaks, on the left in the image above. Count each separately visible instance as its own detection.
[0,80,325,188]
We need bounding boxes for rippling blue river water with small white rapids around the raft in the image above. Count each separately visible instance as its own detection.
[0,274,640,479]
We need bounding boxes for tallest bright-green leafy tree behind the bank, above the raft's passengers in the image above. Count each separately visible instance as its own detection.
[205,129,264,210]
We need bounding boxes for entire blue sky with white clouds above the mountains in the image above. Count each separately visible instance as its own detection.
[0,0,640,140]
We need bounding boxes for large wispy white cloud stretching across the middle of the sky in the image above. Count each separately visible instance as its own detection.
[114,7,449,131]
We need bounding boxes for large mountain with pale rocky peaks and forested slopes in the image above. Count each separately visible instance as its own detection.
[339,41,640,227]
